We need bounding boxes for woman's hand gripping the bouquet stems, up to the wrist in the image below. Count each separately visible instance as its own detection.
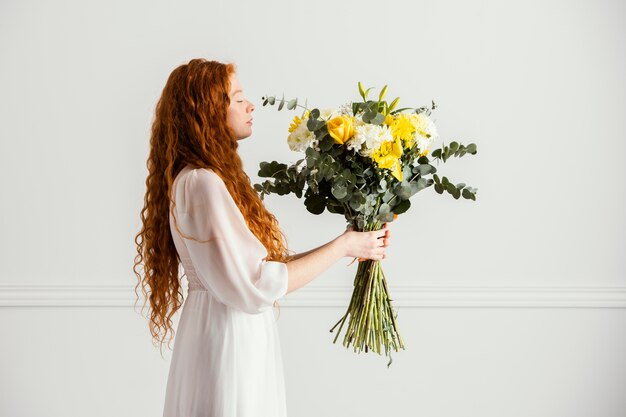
[338,222,391,261]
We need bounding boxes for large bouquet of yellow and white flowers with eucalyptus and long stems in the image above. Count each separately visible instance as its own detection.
[254,82,476,366]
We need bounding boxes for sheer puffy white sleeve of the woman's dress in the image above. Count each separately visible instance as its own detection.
[171,168,288,314]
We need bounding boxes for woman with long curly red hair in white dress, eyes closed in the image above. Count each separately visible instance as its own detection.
[134,59,389,417]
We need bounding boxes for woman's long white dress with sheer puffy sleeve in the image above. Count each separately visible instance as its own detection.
[163,166,288,417]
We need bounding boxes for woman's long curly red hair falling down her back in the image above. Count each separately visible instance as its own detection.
[133,59,291,348]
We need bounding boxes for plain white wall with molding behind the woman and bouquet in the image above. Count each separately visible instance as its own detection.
[0,0,626,417]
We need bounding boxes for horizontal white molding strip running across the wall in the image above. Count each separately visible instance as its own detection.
[0,284,626,308]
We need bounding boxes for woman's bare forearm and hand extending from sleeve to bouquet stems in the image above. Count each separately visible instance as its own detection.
[287,223,390,294]
